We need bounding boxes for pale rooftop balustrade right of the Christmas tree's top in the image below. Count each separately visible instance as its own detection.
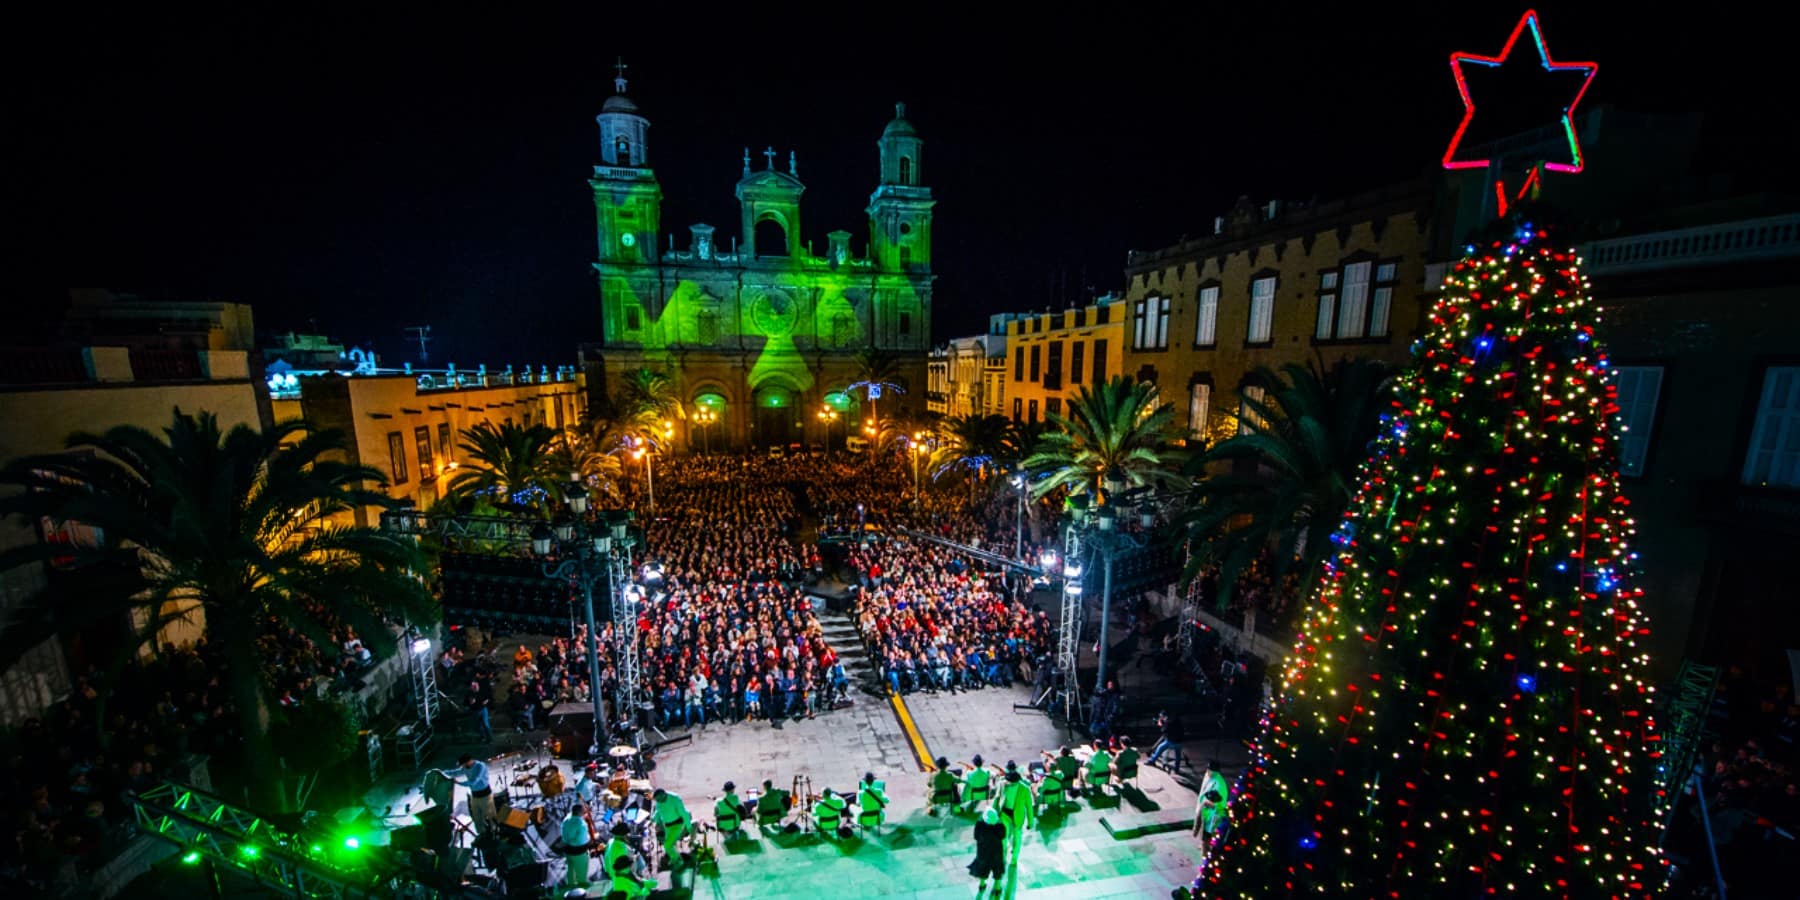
[1580,212,1800,275]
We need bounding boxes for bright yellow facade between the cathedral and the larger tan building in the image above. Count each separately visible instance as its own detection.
[1001,299,1125,425]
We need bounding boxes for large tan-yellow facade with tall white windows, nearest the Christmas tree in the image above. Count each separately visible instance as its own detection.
[1120,182,1433,439]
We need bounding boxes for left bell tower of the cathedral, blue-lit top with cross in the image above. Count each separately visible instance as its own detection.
[589,59,662,263]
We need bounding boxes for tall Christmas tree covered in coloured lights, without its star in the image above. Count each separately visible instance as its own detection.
[1208,225,1663,898]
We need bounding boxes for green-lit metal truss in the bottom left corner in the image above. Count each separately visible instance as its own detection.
[131,781,403,900]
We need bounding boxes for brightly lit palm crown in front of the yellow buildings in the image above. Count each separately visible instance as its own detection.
[1024,376,1183,502]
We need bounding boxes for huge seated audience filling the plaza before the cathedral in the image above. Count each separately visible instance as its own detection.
[454,455,1072,736]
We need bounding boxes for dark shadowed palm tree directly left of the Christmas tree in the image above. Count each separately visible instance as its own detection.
[1181,360,1393,608]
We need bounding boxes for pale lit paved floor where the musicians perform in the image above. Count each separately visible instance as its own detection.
[655,688,1199,898]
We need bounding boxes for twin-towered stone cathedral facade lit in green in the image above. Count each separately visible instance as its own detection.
[589,72,932,450]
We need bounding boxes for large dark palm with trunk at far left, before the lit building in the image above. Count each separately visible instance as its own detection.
[0,409,437,803]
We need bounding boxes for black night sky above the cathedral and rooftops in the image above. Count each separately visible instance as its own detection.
[5,4,1793,364]
